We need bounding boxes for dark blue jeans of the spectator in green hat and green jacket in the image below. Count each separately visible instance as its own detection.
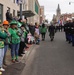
[11,44,19,59]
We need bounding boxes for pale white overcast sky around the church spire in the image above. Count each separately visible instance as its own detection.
[38,0,74,21]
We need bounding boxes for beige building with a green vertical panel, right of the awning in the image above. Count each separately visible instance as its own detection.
[26,0,40,24]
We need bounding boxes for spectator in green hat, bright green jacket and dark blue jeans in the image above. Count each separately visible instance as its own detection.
[9,20,20,63]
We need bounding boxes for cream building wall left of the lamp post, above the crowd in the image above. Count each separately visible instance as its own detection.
[0,0,19,22]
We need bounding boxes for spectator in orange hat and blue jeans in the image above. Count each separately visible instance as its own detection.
[3,21,10,66]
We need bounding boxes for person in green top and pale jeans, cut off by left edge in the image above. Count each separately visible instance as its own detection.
[0,22,7,71]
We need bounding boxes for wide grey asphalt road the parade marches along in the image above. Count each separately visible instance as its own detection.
[21,32,74,75]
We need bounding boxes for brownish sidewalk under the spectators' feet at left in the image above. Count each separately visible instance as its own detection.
[2,44,35,75]
